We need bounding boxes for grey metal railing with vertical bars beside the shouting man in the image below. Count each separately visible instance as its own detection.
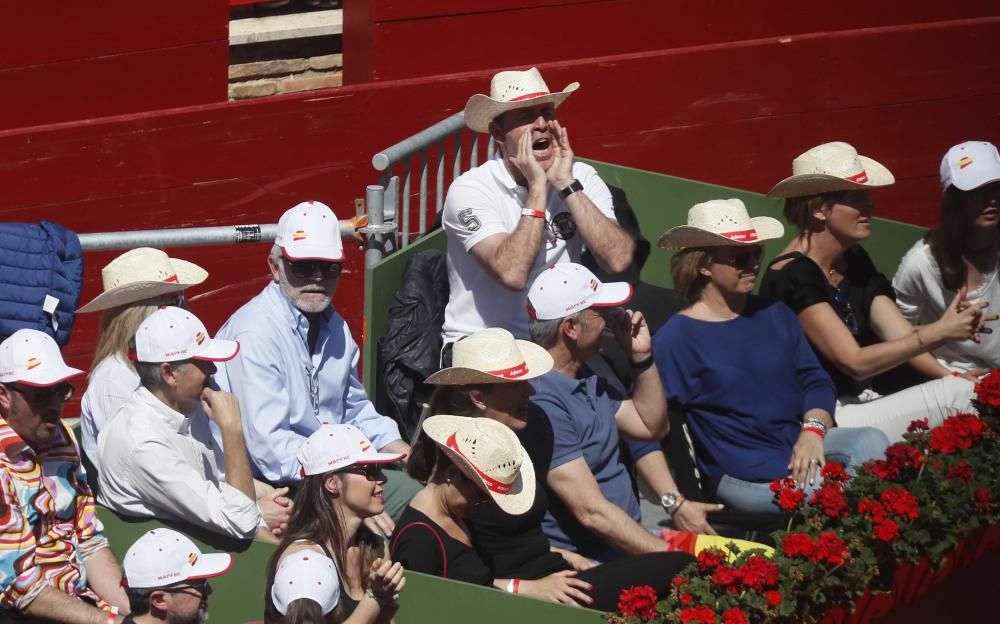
[365,112,494,248]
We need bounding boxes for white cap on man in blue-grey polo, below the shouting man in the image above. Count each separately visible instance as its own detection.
[528,262,632,321]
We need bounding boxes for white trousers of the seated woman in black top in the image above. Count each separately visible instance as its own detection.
[836,377,975,444]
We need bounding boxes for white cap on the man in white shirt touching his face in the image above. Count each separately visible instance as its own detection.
[134,306,240,362]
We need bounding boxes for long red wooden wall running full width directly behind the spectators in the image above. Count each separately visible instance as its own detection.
[0,3,1000,414]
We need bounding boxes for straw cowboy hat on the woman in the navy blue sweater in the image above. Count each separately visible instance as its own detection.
[656,199,785,251]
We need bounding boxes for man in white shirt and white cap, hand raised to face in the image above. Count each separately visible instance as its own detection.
[97,306,266,538]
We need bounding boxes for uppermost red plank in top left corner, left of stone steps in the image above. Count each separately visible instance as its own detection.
[0,0,229,70]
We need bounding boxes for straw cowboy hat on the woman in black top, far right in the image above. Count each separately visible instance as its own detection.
[767,141,896,197]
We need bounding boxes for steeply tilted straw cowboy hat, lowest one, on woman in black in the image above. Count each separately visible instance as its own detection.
[423,415,535,515]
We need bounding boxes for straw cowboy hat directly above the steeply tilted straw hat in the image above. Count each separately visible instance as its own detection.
[424,328,552,386]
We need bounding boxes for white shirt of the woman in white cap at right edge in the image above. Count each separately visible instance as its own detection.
[892,240,1000,371]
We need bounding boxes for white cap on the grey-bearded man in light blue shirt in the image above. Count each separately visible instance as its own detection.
[274,201,344,262]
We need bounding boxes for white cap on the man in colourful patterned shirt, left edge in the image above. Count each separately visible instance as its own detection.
[0,329,83,387]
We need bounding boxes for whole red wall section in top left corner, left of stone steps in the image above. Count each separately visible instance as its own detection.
[0,0,229,129]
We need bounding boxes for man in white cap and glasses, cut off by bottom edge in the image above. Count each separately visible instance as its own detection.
[122,529,233,624]
